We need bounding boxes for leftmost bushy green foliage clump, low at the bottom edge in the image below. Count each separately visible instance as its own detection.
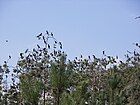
[20,74,43,105]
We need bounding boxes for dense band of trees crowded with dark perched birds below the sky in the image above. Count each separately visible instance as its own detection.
[0,31,140,105]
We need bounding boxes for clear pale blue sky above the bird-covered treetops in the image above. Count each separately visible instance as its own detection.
[0,0,140,65]
